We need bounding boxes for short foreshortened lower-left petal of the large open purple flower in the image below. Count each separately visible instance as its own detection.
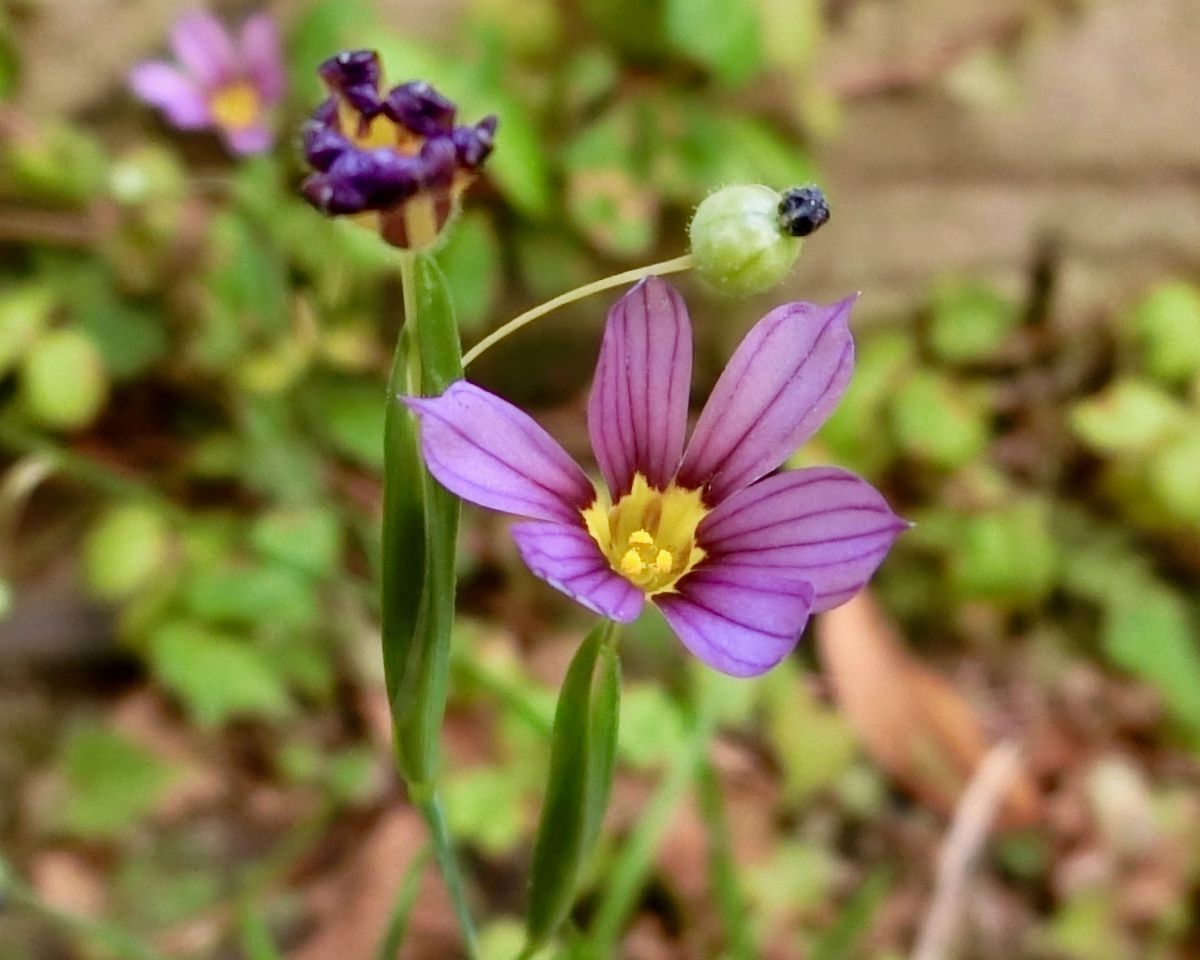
[512,521,644,623]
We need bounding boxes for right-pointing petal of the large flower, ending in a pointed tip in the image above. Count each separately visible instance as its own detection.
[696,467,908,613]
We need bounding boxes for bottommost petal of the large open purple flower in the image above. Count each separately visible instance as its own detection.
[654,560,812,677]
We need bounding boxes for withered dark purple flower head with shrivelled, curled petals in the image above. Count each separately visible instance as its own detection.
[302,50,497,247]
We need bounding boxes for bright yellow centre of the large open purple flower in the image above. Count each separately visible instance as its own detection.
[583,474,708,596]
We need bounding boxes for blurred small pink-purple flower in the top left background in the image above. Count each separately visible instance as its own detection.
[130,11,287,154]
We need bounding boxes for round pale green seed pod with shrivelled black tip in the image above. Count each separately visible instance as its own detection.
[689,184,829,296]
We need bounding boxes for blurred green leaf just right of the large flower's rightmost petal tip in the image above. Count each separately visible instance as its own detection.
[950,499,1061,604]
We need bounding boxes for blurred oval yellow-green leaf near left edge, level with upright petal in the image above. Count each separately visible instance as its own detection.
[20,329,108,430]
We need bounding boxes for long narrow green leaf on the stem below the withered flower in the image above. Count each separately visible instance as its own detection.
[383,254,462,784]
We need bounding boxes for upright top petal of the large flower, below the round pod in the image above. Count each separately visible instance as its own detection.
[588,277,691,500]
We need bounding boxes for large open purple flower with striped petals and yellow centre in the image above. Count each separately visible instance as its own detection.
[404,280,907,677]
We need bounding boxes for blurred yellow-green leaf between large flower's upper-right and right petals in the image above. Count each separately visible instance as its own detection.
[892,370,988,469]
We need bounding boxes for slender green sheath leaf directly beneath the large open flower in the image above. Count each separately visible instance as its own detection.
[526,622,620,953]
